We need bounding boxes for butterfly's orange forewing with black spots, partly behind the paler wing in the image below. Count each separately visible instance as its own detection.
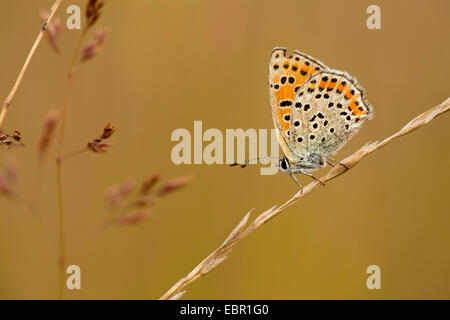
[269,47,328,162]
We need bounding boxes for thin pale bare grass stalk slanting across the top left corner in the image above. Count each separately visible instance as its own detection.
[0,0,62,127]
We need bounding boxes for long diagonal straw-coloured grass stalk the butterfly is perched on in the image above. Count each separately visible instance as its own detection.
[159,98,450,300]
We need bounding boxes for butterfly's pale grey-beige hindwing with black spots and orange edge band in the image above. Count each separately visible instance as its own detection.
[287,70,373,160]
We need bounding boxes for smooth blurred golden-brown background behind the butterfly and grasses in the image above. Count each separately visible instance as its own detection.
[0,0,450,299]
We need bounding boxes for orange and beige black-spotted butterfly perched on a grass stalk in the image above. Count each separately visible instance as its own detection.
[268,47,373,188]
